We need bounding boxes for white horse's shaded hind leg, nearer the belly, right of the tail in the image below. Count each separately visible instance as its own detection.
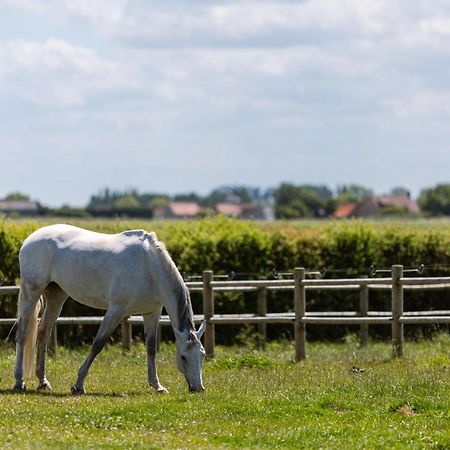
[36,283,67,389]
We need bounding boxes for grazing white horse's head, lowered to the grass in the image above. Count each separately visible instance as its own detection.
[174,322,206,392]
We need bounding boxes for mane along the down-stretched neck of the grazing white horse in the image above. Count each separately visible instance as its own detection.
[145,232,195,331]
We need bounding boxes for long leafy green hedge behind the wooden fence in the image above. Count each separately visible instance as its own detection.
[0,218,450,343]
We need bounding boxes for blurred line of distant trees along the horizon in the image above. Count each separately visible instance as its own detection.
[3,183,450,219]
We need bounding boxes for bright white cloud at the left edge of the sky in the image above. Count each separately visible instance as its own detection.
[0,39,133,106]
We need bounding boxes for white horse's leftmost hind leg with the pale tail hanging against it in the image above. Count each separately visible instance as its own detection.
[14,282,42,391]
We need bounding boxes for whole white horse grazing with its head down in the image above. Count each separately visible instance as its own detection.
[14,225,205,394]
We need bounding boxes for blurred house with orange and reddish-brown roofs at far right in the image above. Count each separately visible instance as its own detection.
[333,195,420,219]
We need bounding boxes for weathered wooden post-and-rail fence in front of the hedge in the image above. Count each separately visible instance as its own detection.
[0,265,450,361]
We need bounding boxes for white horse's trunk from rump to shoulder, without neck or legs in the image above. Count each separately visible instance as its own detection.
[20,225,156,308]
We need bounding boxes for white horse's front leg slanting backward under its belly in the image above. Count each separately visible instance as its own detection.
[71,309,125,395]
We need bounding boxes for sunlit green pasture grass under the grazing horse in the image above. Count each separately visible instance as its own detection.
[0,335,450,449]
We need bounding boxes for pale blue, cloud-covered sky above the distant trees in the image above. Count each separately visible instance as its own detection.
[0,0,450,206]
